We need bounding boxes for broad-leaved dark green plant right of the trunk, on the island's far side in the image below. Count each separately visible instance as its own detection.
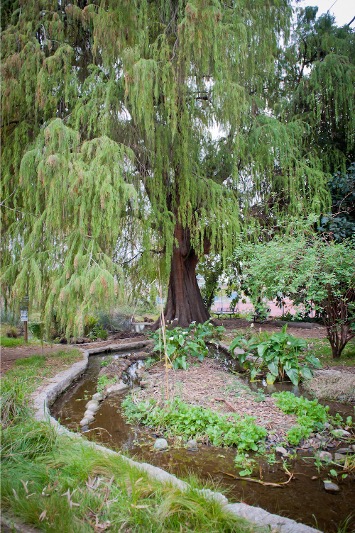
[229,325,321,385]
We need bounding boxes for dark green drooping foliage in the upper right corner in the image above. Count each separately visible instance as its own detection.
[284,7,355,174]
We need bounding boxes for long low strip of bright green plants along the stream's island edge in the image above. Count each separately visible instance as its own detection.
[122,396,267,451]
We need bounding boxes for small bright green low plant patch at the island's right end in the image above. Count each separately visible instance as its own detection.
[273,391,329,446]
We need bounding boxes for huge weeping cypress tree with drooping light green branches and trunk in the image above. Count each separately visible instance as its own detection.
[1,0,329,334]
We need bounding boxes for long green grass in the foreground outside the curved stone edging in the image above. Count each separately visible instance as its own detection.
[1,342,262,533]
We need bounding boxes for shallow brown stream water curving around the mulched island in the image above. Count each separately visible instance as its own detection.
[51,353,355,533]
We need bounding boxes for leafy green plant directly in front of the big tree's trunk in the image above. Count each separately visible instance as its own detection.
[152,322,224,370]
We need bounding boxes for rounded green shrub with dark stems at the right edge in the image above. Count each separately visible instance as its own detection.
[234,232,355,358]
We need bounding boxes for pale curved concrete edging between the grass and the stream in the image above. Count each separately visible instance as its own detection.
[32,341,320,533]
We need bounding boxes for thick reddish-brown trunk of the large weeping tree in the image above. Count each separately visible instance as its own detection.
[157,224,210,327]
